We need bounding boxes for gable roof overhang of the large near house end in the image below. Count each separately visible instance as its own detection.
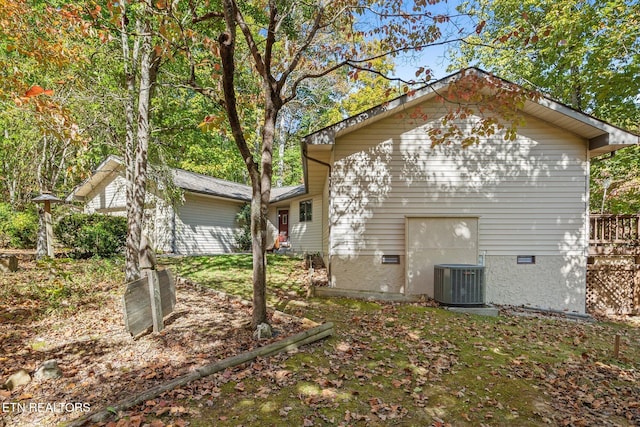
[303,67,640,157]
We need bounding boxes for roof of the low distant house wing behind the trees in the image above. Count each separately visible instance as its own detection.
[66,156,306,202]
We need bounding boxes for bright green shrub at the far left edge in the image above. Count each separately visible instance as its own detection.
[0,203,38,249]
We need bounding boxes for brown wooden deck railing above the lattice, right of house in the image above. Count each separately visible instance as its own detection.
[589,214,640,246]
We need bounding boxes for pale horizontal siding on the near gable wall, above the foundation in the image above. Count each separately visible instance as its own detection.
[330,102,588,256]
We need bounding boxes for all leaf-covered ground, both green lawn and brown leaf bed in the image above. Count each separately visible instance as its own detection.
[0,255,640,426]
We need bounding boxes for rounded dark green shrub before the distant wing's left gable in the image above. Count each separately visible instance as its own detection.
[54,213,127,258]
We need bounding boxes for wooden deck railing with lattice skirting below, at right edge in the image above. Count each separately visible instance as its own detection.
[587,215,640,315]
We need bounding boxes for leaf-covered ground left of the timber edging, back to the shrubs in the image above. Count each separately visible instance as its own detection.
[0,260,305,426]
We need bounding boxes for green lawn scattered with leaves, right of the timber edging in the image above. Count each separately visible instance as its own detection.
[163,255,640,426]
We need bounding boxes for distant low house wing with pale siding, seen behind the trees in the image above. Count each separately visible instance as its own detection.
[68,156,304,255]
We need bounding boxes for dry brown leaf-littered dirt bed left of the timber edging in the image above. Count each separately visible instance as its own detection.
[0,268,313,427]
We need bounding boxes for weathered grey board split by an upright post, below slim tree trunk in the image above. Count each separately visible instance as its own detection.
[123,270,176,336]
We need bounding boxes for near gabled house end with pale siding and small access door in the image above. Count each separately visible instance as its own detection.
[302,69,639,313]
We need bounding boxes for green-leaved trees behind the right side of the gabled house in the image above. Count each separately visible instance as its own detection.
[456,0,640,213]
